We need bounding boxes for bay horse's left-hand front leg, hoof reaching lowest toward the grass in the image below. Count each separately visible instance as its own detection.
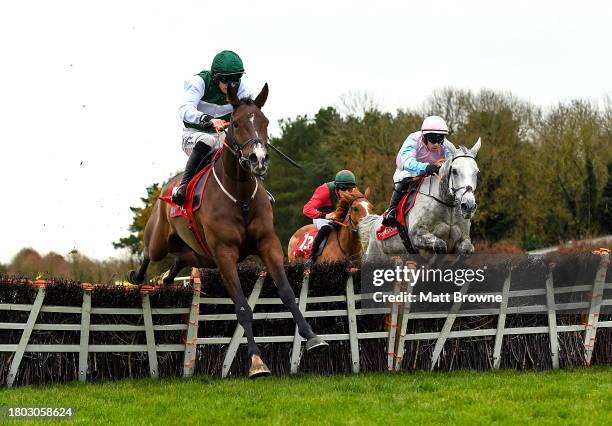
[213,246,270,377]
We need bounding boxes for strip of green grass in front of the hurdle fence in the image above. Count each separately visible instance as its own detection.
[0,366,612,425]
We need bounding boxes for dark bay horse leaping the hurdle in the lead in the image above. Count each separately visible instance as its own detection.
[129,83,328,377]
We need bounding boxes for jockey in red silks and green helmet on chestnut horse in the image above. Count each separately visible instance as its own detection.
[302,170,357,263]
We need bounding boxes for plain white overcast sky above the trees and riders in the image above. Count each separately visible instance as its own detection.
[0,0,612,263]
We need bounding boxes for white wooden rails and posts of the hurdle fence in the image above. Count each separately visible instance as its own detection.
[0,253,612,387]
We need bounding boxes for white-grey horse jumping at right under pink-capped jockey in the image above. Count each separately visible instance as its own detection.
[359,138,481,259]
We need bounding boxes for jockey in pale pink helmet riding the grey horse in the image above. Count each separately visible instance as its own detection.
[382,115,449,226]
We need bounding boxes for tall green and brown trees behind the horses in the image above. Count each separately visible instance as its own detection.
[114,88,612,254]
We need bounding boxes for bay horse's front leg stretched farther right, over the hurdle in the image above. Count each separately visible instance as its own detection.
[258,234,329,351]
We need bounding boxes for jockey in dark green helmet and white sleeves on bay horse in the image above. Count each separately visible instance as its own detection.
[172,50,251,205]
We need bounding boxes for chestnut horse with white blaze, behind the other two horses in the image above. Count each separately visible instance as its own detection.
[287,188,373,263]
